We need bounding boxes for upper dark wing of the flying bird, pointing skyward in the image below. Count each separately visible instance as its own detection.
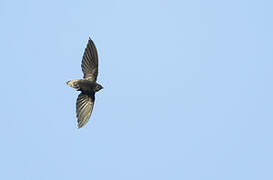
[81,38,98,81]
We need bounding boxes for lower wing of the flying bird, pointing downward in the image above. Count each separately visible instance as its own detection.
[76,92,95,128]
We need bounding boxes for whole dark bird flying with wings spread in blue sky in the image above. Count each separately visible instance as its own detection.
[66,37,103,128]
